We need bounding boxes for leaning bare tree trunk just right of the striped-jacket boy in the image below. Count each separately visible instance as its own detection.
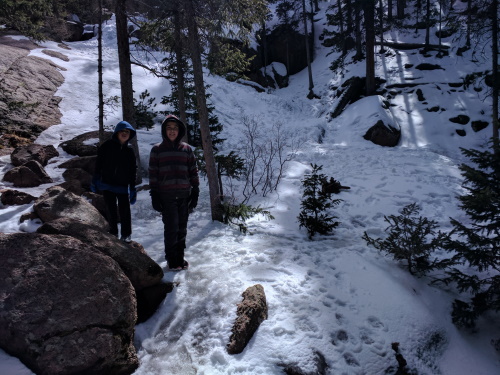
[184,0,223,222]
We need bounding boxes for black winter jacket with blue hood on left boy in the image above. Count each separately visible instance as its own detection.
[94,121,137,193]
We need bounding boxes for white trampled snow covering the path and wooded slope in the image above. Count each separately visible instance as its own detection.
[0,3,500,375]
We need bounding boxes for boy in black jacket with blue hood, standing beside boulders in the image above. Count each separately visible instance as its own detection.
[91,121,137,242]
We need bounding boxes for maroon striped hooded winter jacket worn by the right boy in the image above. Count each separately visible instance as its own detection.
[149,116,200,196]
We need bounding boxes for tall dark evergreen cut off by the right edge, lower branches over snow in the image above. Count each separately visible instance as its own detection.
[443,138,500,327]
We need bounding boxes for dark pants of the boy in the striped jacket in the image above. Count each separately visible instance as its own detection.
[160,192,189,268]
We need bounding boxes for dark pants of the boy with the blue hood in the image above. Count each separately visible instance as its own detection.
[102,190,132,237]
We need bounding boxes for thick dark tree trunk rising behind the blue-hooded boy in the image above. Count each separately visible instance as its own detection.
[115,0,142,184]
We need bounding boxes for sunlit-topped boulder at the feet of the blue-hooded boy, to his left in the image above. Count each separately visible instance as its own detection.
[33,186,109,230]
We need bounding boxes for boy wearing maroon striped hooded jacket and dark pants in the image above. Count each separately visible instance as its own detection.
[149,115,200,271]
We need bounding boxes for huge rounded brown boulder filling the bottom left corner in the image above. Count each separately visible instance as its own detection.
[0,233,138,375]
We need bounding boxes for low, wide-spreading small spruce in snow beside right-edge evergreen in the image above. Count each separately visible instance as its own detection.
[363,203,449,275]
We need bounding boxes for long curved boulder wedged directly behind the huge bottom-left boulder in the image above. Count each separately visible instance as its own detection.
[37,218,163,290]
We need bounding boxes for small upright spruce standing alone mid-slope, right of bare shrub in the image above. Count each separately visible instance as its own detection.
[297,164,342,239]
